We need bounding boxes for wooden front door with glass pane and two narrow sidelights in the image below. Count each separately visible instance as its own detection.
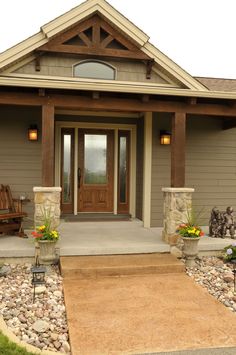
[60,127,135,215]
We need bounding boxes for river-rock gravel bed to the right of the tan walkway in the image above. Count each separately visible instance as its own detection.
[186,256,236,312]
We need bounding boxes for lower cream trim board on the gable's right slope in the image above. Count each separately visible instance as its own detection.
[141,42,208,91]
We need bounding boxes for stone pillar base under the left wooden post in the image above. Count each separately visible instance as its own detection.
[33,187,61,229]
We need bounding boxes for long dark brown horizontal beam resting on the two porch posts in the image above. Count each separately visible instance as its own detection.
[0,91,236,118]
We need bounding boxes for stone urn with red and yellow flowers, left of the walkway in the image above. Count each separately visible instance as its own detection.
[32,212,60,265]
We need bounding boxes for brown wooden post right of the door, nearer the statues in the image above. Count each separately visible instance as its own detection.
[171,112,186,187]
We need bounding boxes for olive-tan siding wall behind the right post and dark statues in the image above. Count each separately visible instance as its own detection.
[151,114,236,227]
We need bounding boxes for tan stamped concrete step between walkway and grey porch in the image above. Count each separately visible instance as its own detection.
[60,253,185,279]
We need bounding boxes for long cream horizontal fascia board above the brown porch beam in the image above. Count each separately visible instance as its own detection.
[0,75,236,100]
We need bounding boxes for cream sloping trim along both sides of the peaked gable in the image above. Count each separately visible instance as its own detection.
[0,0,208,91]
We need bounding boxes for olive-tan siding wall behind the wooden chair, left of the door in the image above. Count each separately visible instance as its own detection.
[0,106,41,222]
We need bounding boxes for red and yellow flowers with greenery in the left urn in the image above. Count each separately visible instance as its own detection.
[32,210,60,241]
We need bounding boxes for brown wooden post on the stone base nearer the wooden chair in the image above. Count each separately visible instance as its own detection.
[42,105,54,187]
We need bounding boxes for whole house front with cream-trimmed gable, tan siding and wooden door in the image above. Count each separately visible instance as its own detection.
[0,0,236,239]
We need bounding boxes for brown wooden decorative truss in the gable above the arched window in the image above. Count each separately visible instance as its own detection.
[35,15,154,78]
